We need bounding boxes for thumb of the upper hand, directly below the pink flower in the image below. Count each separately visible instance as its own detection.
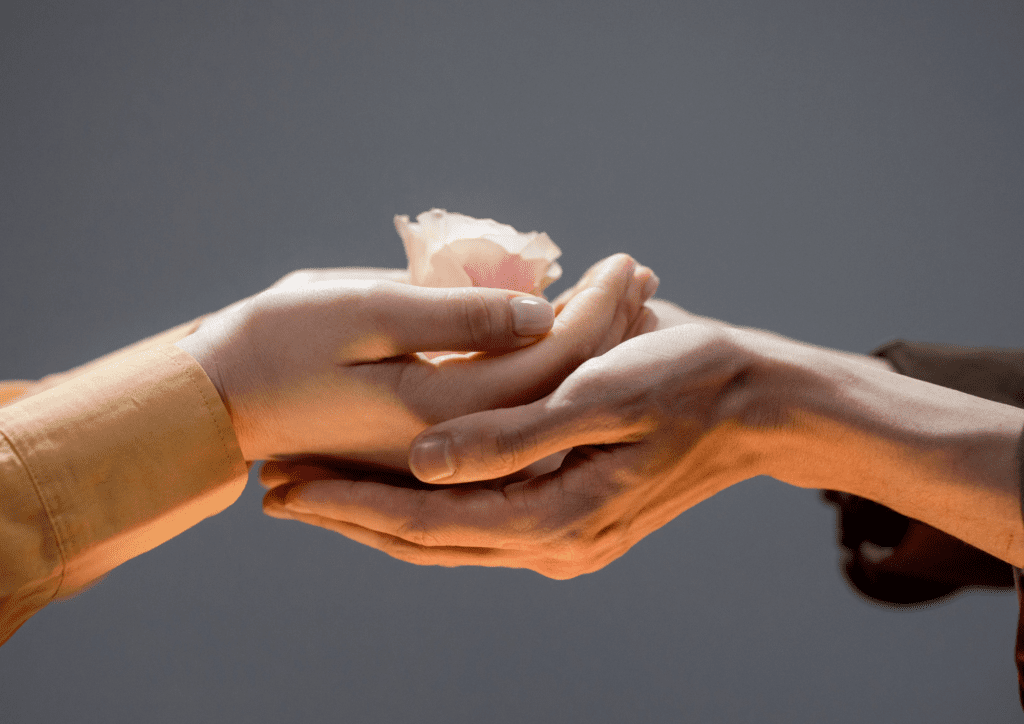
[371,284,555,354]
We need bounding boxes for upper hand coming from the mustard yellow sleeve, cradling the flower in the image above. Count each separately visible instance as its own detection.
[178,254,653,469]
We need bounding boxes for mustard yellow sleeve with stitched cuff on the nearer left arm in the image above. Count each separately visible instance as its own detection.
[0,321,249,643]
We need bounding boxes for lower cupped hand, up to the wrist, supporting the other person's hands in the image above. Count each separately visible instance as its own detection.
[261,321,761,579]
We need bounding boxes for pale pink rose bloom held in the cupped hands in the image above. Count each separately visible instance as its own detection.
[394,209,562,296]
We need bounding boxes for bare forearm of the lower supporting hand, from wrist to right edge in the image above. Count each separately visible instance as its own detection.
[755,331,1024,566]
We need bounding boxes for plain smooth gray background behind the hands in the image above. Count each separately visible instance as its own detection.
[0,0,1024,723]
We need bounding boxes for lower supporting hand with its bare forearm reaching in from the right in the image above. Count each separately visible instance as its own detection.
[261,292,1024,579]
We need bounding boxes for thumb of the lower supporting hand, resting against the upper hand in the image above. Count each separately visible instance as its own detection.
[409,396,593,484]
